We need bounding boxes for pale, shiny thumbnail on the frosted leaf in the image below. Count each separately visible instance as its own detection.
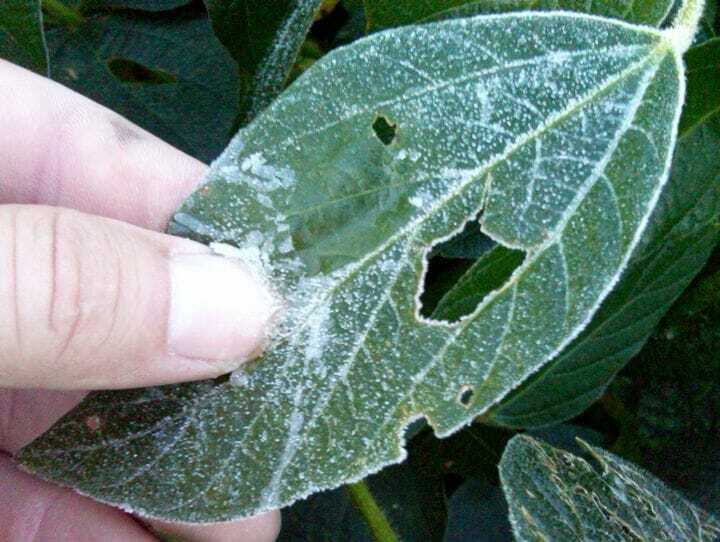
[168,250,278,368]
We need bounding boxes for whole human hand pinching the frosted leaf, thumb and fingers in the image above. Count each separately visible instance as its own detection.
[0,60,280,542]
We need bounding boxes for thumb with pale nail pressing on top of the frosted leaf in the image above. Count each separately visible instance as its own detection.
[0,205,276,389]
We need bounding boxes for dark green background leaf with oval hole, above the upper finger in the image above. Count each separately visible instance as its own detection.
[48,8,238,161]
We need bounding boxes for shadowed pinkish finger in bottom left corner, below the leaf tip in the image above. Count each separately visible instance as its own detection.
[0,456,155,542]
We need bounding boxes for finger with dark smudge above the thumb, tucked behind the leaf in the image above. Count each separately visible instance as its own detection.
[0,60,205,230]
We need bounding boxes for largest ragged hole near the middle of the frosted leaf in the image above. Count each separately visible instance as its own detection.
[420,220,525,323]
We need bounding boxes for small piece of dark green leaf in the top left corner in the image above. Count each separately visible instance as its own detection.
[0,0,48,75]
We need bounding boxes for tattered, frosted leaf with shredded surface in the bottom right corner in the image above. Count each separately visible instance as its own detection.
[500,436,720,541]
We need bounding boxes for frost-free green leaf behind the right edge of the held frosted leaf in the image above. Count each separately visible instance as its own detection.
[490,40,720,427]
